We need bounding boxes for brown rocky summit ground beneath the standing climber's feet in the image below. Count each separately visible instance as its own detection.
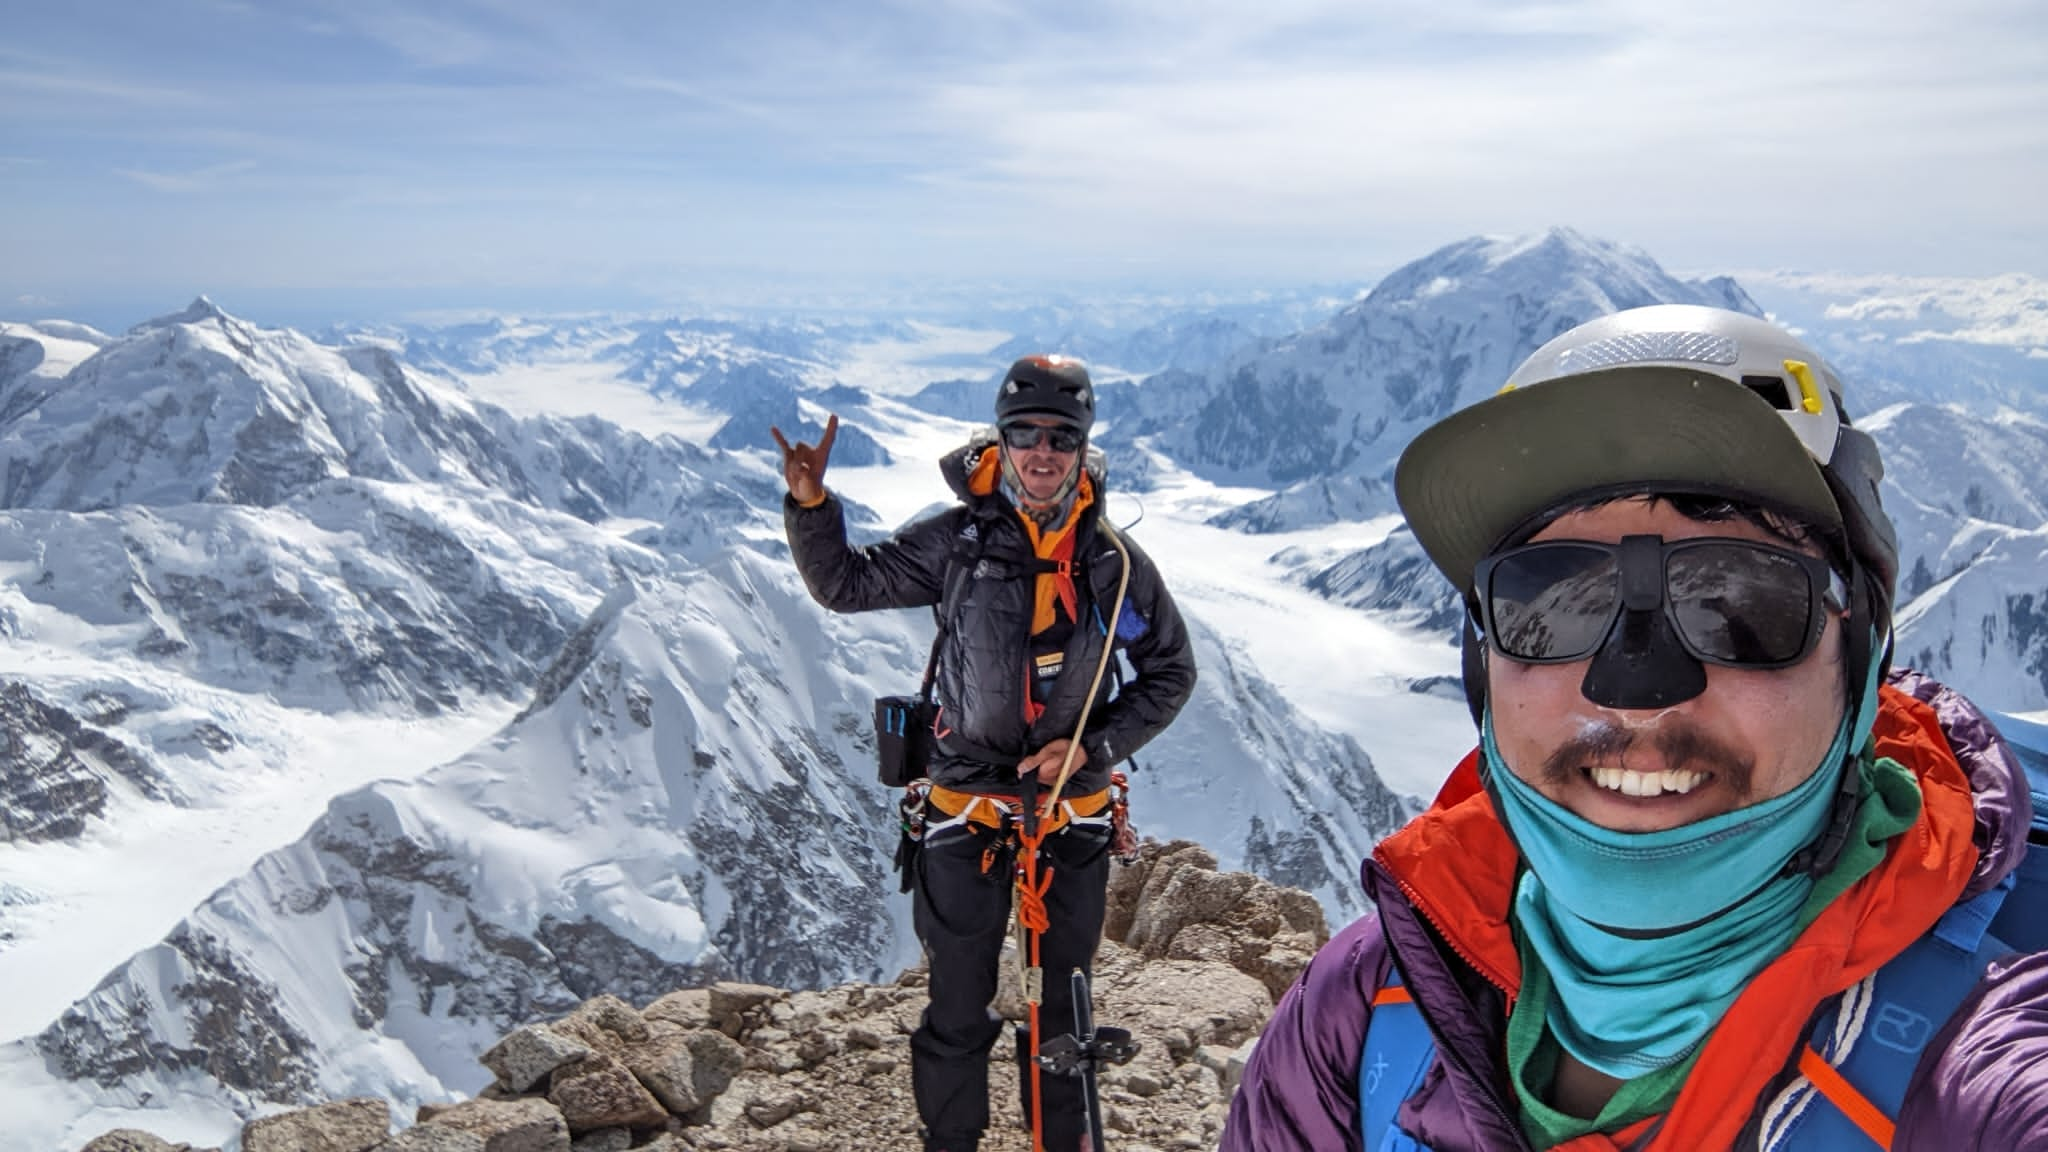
[86,840,1329,1152]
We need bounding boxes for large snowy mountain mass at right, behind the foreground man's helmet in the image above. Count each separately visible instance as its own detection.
[1187,230,2048,709]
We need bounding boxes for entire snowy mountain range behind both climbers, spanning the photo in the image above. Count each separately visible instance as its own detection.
[0,230,2048,1148]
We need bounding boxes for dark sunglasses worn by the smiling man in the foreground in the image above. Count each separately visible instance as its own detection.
[1473,535,1849,668]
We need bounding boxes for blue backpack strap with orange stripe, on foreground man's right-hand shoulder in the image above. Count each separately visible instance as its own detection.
[1759,869,2023,1152]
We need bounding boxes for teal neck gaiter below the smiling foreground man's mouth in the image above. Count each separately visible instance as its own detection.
[1481,668,1876,1080]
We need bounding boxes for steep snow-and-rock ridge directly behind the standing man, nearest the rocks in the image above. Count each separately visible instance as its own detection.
[0,528,1411,1138]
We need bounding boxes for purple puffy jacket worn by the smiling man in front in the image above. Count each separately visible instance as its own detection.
[1221,672,2048,1152]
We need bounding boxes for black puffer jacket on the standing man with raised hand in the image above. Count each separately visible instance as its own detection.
[782,435,1194,795]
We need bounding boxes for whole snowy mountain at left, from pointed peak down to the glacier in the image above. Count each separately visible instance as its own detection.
[0,301,774,713]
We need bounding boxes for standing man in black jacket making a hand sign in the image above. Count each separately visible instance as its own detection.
[774,357,1194,1152]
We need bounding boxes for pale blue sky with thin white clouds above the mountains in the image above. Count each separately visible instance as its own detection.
[0,0,2048,324]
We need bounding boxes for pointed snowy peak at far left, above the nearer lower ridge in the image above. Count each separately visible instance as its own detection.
[0,297,774,521]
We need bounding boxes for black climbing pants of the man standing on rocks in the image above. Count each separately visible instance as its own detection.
[909,824,1110,1152]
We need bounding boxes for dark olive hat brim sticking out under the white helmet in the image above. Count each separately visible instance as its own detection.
[1395,367,1841,594]
